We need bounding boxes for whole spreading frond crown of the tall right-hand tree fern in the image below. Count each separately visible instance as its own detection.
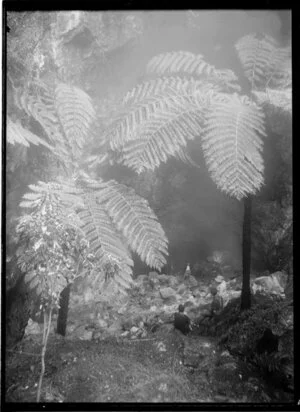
[102,35,290,200]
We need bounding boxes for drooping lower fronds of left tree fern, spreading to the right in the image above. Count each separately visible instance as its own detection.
[20,175,168,292]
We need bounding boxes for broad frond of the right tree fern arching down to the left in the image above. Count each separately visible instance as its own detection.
[106,78,217,172]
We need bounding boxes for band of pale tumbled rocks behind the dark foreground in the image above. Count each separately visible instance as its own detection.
[26,260,286,340]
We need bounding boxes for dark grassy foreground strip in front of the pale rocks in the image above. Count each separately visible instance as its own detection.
[5,330,293,403]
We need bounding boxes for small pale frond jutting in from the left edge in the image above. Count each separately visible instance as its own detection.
[6,117,54,151]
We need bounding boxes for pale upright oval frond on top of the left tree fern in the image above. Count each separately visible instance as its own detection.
[55,83,96,157]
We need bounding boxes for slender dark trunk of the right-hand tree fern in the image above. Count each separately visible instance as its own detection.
[241,196,252,310]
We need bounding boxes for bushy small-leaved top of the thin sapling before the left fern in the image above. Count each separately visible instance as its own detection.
[16,190,91,307]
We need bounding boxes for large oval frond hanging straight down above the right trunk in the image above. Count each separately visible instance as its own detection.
[202,94,265,199]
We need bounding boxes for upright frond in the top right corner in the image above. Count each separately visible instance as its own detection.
[235,34,290,90]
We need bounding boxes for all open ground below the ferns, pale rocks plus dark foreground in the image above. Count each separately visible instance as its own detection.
[6,254,292,402]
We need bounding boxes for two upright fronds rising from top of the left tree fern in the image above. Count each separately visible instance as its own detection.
[15,81,96,167]
